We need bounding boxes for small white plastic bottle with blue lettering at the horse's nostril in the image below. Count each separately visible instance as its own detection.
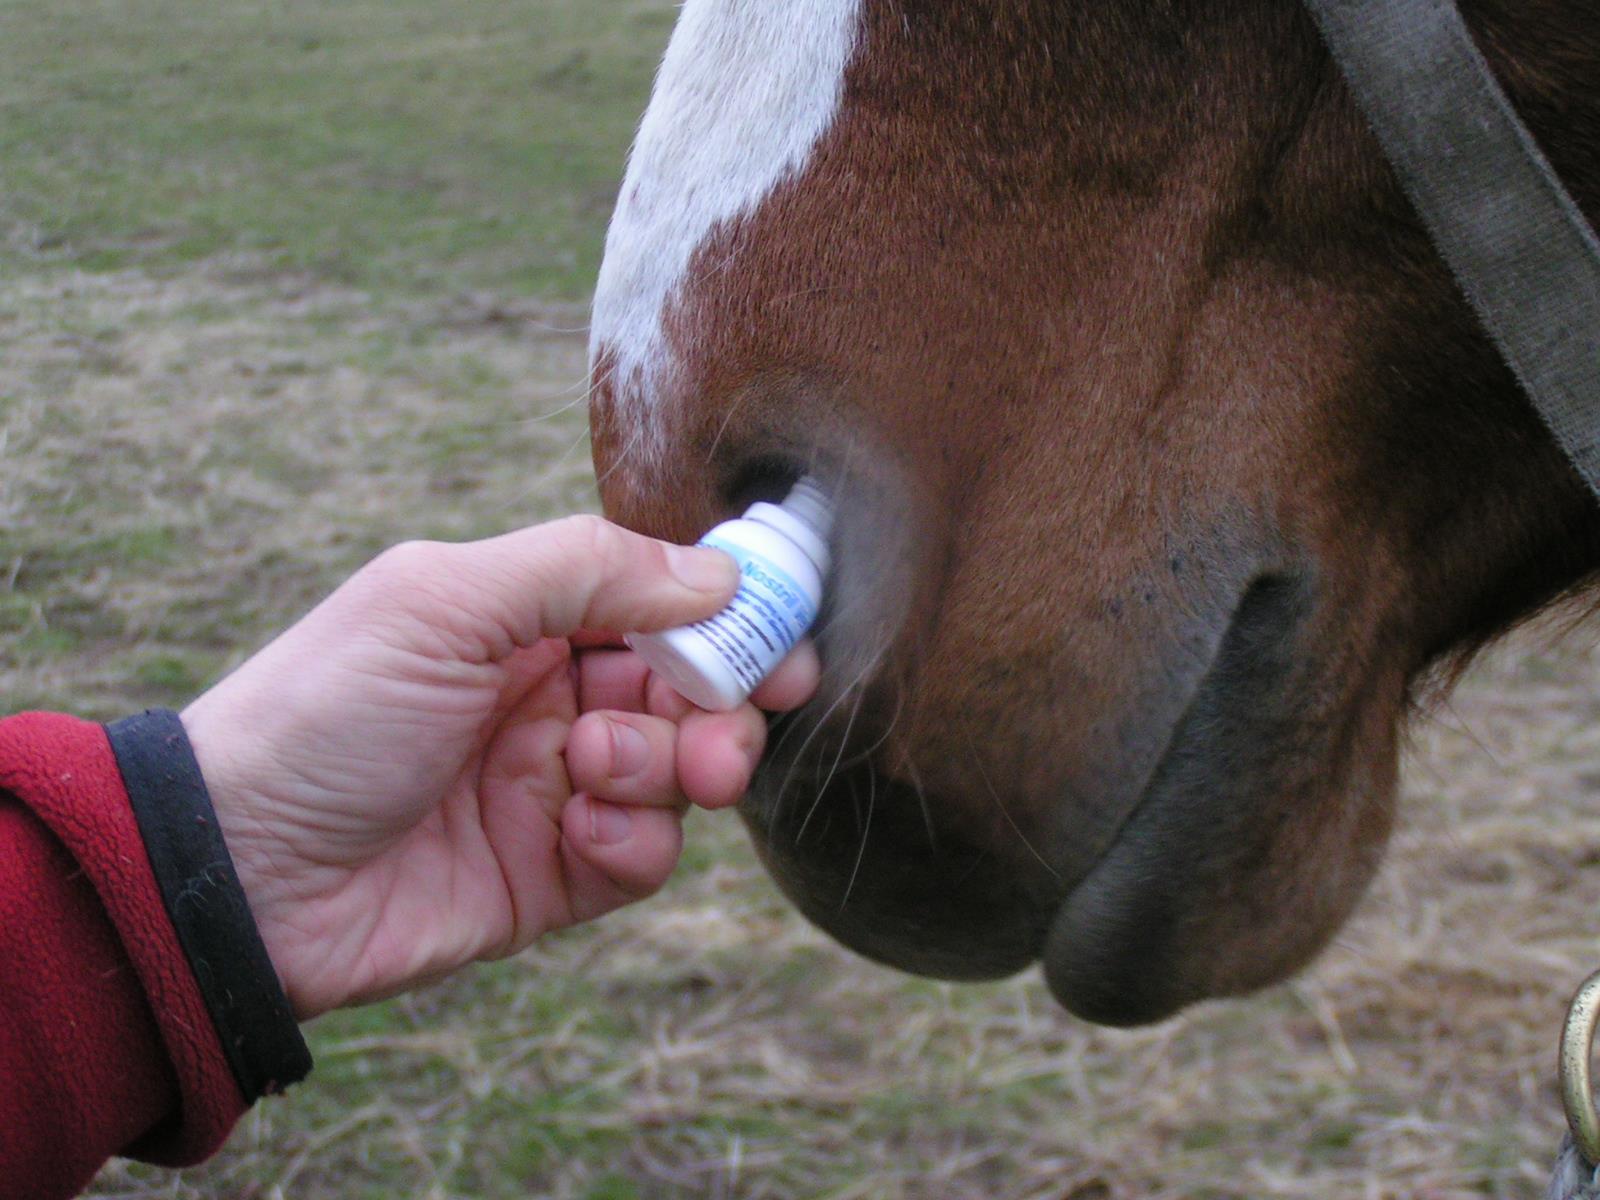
[627,477,834,712]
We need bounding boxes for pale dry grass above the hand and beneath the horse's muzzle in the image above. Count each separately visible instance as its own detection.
[9,261,1600,1200]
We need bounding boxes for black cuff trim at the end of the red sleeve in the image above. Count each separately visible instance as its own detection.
[106,709,310,1104]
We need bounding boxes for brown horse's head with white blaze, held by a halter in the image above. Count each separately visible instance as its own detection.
[592,0,1600,1022]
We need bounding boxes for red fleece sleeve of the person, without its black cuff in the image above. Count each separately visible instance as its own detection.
[0,714,245,1200]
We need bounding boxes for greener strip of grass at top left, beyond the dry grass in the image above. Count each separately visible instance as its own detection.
[0,0,674,298]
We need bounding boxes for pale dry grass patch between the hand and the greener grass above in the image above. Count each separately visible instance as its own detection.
[0,258,592,715]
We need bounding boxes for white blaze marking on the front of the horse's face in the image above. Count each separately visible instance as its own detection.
[589,0,862,438]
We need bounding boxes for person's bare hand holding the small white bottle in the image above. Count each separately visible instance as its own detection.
[182,517,818,1019]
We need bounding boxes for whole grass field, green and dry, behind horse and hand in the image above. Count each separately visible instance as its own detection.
[9,0,1600,1200]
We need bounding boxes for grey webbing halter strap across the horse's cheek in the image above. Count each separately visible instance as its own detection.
[1306,0,1600,496]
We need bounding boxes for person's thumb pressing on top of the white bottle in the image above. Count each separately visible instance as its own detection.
[384,517,739,646]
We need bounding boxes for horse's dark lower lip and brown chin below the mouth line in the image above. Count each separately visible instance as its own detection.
[1043,579,1405,1026]
